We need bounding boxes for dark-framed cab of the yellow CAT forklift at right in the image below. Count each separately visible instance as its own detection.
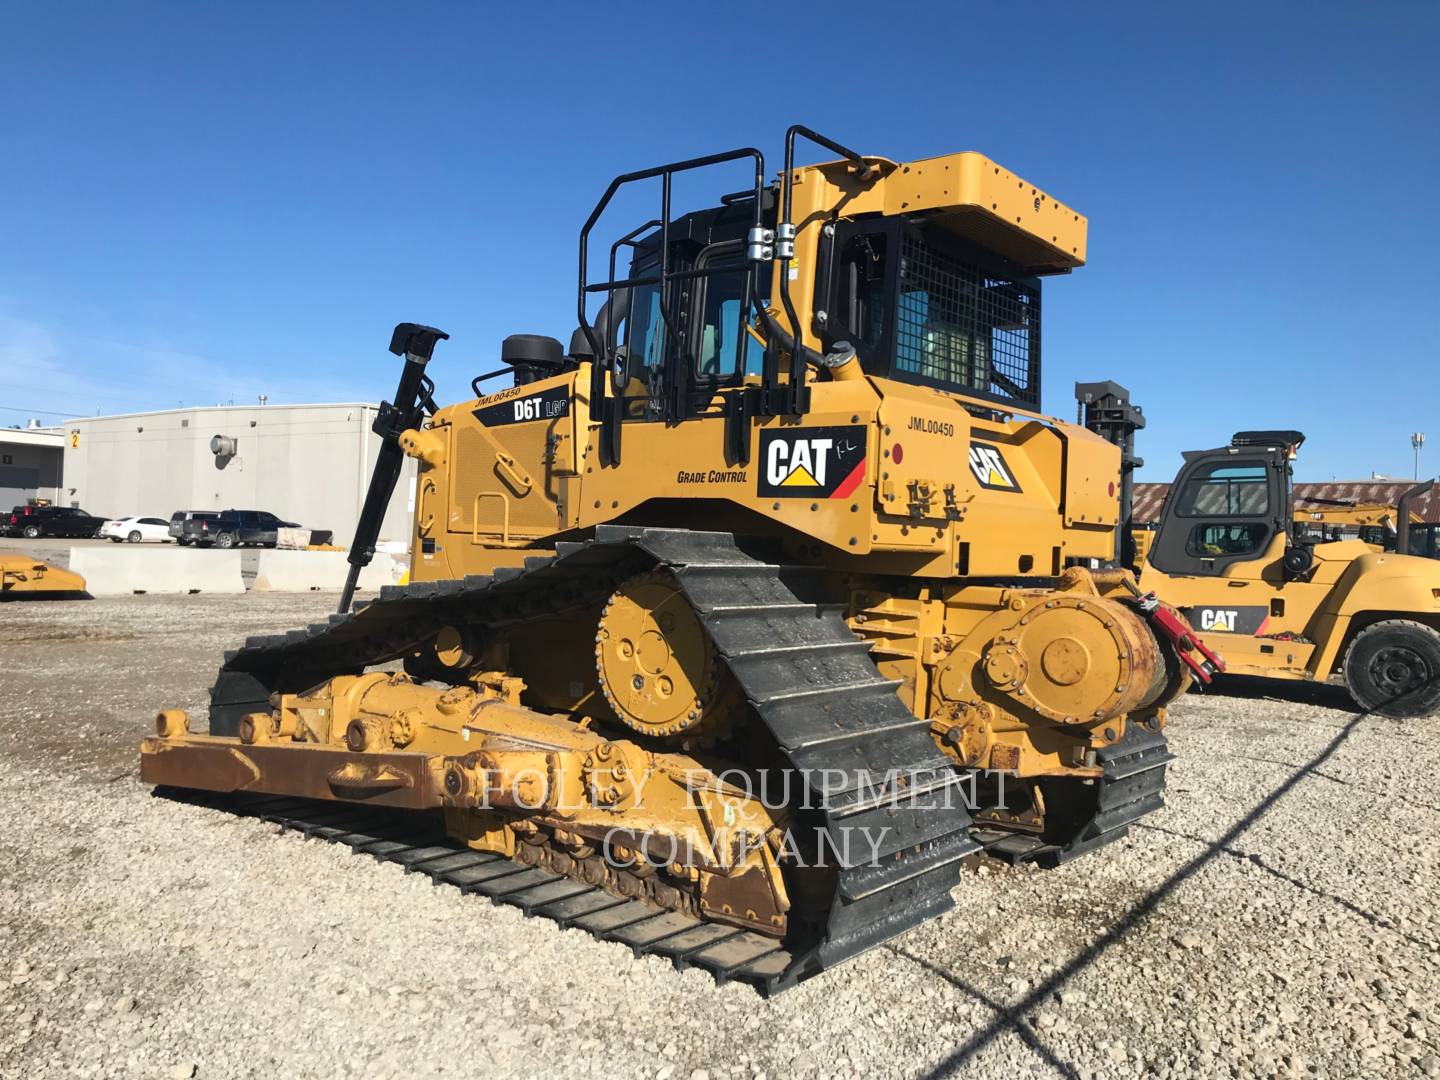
[1149,431,1312,577]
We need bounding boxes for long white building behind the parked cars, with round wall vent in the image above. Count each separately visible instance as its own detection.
[64,405,415,547]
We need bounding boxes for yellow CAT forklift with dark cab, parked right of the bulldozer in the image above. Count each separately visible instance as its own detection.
[1076,383,1440,717]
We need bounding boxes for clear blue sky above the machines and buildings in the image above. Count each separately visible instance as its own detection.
[0,0,1440,480]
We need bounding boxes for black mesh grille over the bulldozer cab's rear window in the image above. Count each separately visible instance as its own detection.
[896,232,1040,409]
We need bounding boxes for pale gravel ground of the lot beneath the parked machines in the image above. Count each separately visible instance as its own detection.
[0,595,1440,1080]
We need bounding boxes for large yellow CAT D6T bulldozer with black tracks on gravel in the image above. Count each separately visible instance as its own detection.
[141,127,1217,992]
